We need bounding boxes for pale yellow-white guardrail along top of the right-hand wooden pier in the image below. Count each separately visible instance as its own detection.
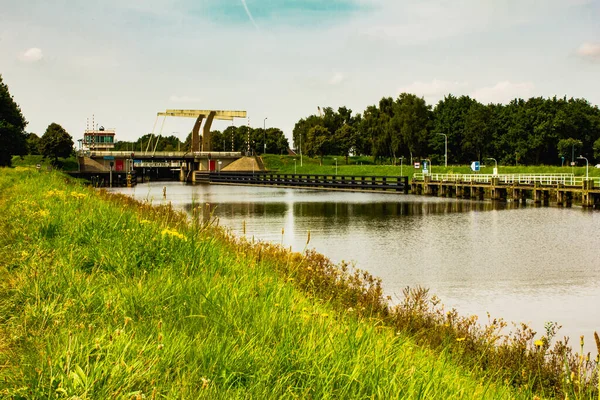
[413,173,600,186]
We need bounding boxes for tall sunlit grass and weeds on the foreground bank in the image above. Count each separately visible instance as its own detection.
[0,168,600,399]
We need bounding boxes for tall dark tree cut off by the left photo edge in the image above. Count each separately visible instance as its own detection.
[0,75,27,166]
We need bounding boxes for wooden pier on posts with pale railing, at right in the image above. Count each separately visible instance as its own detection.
[411,174,600,208]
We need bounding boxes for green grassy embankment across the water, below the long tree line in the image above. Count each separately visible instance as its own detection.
[263,154,600,178]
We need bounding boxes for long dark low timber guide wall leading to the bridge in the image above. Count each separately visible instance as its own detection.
[194,171,409,193]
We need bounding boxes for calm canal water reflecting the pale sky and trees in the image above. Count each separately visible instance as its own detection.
[112,182,600,354]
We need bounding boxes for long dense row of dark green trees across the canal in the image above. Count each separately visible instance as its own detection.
[293,93,600,165]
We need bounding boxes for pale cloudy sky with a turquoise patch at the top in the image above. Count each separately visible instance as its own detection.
[0,0,600,143]
